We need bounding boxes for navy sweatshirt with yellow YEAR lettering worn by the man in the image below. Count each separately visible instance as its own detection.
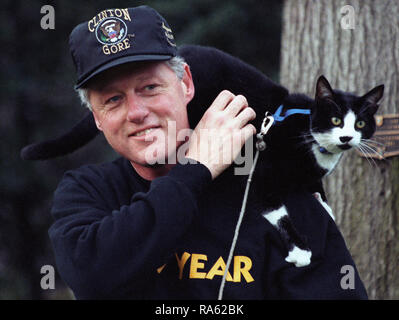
[49,158,367,299]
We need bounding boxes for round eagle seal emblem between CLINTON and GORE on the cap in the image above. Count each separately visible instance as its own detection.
[96,17,127,44]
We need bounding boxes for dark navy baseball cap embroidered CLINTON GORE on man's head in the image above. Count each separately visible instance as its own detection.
[69,6,177,89]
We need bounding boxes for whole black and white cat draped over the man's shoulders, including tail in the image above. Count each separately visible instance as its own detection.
[21,45,384,267]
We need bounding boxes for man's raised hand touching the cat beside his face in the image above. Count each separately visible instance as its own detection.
[186,90,256,179]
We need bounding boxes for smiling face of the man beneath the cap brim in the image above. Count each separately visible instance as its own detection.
[89,62,194,173]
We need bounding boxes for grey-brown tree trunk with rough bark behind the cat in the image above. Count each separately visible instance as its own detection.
[280,0,399,299]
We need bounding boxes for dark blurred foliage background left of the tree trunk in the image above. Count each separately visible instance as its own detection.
[0,0,282,299]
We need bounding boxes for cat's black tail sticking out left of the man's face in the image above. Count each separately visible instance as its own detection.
[21,112,99,160]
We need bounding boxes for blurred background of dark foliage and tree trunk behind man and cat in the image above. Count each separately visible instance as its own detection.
[0,0,399,299]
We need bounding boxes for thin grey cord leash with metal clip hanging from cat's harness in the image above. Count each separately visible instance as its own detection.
[218,111,281,300]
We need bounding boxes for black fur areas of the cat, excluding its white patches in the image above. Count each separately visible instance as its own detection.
[21,45,383,264]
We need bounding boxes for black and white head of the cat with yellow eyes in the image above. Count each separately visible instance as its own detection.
[311,76,384,154]
